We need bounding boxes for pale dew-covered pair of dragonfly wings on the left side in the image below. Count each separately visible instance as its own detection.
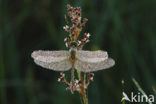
[31,50,71,71]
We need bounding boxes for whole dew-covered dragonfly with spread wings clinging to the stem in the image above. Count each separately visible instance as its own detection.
[31,41,115,92]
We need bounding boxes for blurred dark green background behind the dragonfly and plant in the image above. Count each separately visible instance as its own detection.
[0,0,156,104]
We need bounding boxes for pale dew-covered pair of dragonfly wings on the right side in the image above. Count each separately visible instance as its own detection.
[75,51,115,72]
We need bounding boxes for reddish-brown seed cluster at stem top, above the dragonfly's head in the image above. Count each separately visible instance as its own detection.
[63,5,90,47]
